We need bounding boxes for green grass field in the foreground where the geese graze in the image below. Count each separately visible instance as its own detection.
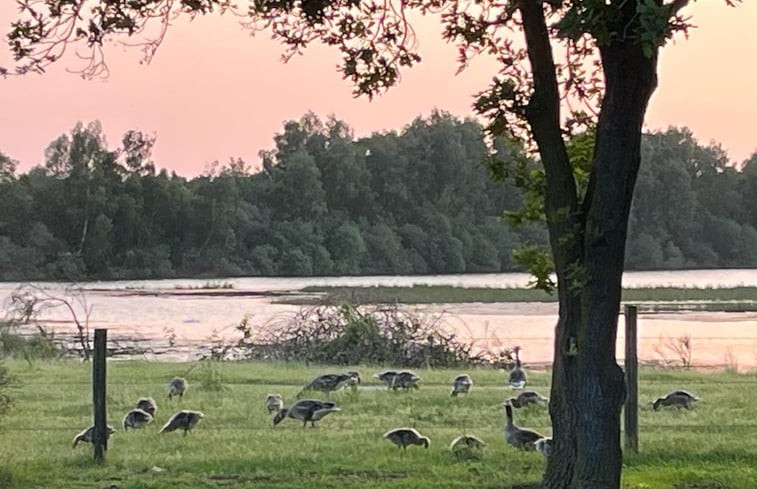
[0,361,757,489]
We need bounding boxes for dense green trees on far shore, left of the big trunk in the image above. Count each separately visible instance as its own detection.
[0,114,532,280]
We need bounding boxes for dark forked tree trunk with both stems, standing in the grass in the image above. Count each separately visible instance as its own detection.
[520,0,657,489]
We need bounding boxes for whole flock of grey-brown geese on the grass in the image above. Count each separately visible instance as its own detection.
[73,346,699,458]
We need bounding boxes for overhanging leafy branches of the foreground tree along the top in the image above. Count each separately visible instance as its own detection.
[0,0,738,139]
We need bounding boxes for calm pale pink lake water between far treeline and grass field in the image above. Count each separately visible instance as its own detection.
[0,270,757,368]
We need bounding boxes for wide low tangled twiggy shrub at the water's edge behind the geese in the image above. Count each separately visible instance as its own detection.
[236,305,486,367]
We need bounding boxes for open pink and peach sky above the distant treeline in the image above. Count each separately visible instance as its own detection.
[0,0,757,176]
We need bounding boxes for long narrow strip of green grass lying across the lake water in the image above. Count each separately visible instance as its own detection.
[279,285,757,310]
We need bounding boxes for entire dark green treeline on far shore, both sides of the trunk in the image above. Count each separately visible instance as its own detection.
[0,113,757,280]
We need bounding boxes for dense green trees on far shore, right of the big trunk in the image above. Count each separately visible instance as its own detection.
[626,129,757,269]
